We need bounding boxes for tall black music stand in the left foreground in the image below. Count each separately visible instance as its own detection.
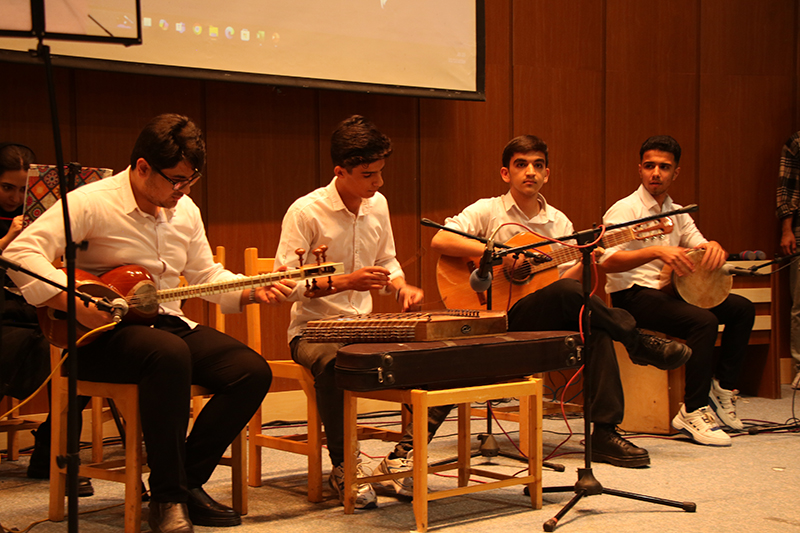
[0,0,142,533]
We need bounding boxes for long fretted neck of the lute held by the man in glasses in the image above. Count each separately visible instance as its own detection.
[156,263,344,303]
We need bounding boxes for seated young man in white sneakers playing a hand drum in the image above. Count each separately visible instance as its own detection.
[601,135,755,446]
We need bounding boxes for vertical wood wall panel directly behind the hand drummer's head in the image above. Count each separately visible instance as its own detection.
[605,0,704,217]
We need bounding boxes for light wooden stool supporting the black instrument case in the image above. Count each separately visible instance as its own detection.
[344,378,542,532]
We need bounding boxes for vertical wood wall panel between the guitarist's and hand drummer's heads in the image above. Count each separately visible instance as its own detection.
[512,0,604,229]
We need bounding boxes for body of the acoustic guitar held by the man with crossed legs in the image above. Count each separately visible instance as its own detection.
[436,233,558,311]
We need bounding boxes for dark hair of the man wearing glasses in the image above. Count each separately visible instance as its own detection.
[131,114,206,171]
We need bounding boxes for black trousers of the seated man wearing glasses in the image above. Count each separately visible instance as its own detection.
[78,315,272,502]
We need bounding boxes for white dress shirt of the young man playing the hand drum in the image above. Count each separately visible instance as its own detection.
[600,185,708,294]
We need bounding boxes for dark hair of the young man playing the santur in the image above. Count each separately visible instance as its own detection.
[331,115,392,168]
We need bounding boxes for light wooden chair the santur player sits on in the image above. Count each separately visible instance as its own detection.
[244,248,406,502]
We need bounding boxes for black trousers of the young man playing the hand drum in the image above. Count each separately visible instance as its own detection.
[611,285,755,412]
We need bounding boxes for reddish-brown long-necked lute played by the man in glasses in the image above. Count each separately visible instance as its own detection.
[36,263,344,348]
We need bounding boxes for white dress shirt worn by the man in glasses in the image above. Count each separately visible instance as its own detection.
[4,167,241,327]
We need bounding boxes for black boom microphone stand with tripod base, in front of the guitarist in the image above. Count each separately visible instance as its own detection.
[500,204,697,531]
